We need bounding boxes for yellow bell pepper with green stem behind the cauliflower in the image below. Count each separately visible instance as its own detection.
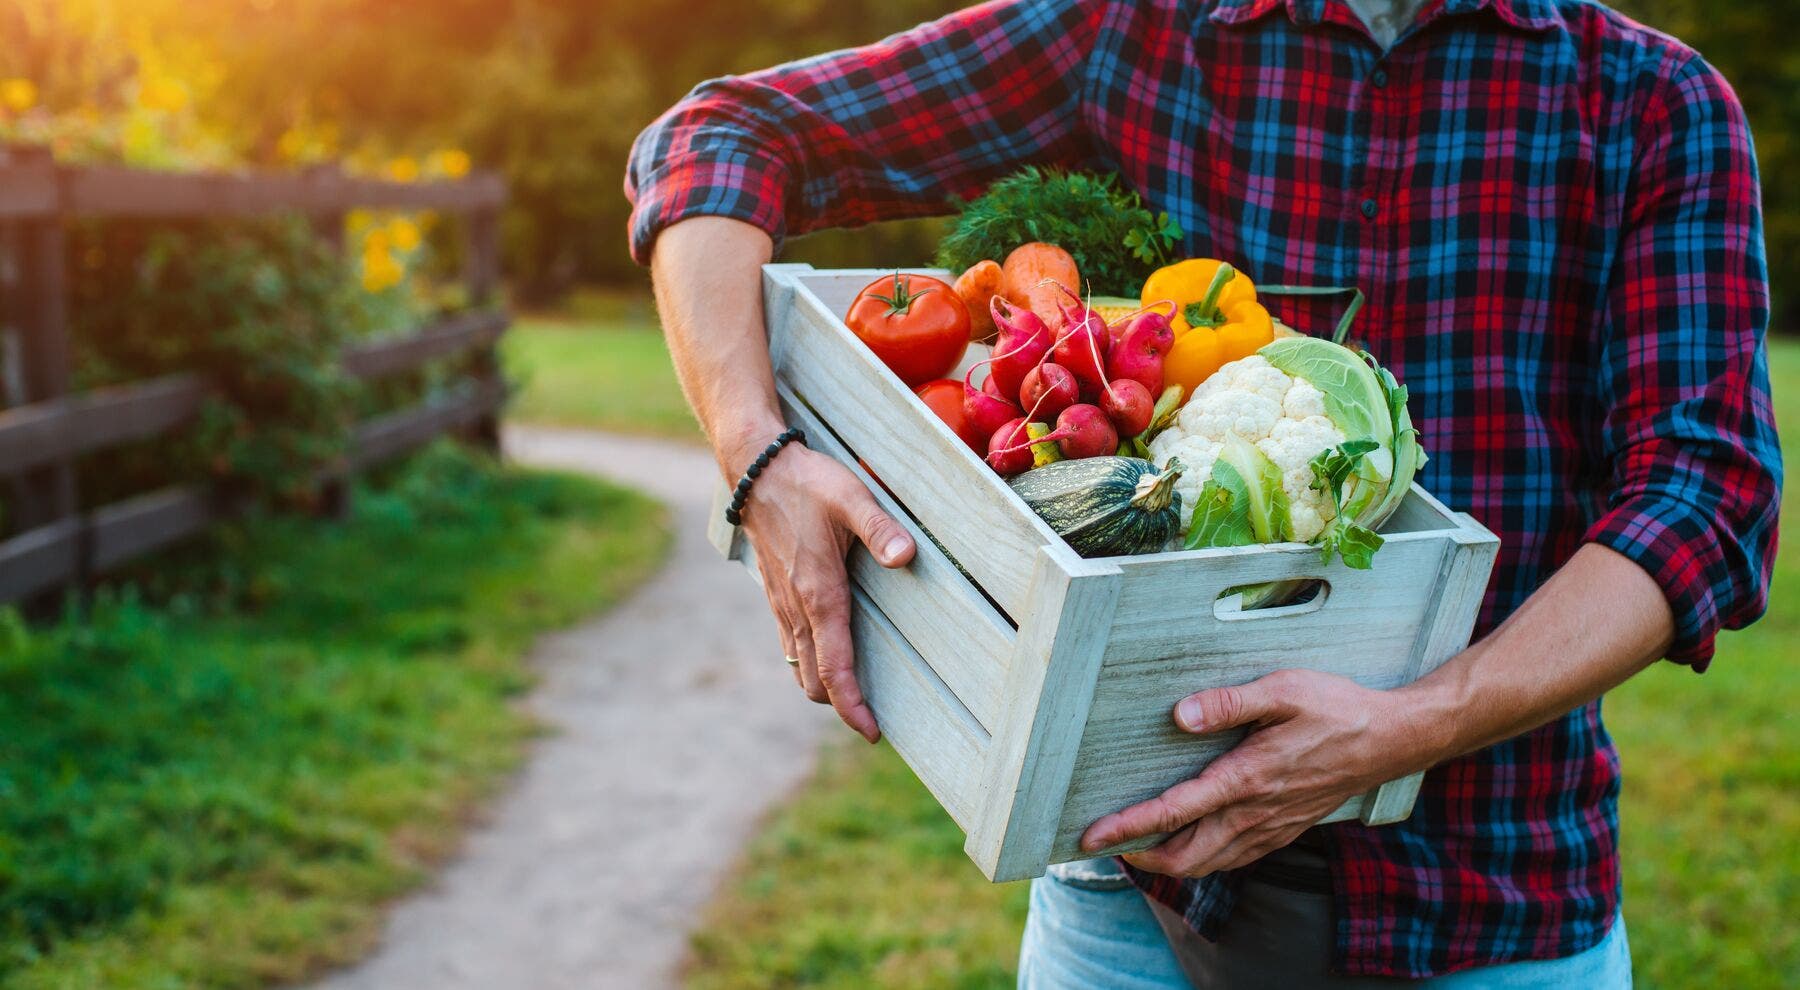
[1143,257,1274,394]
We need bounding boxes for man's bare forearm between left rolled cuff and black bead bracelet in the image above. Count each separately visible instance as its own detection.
[652,216,785,477]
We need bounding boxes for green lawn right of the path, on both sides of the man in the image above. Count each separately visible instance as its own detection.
[689,340,1800,990]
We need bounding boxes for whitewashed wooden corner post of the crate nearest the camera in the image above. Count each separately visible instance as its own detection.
[963,544,1120,884]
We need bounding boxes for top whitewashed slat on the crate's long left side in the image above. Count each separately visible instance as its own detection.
[769,270,1058,619]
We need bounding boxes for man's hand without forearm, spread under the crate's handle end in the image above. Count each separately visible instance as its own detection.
[1082,670,1431,877]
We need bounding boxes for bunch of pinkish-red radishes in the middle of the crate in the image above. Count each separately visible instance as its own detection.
[963,283,1175,477]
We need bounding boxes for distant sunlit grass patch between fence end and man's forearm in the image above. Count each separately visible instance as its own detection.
[502,293,702,443]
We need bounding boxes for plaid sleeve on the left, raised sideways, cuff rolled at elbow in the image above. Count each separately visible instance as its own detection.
[625,0,1102,263]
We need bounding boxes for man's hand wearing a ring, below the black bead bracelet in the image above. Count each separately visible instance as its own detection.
[743,443,913,742]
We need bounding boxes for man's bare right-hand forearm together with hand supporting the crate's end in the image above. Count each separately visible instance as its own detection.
[1082,544,1674,877]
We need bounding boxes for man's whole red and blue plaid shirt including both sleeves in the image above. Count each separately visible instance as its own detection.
[626,0,1780,977]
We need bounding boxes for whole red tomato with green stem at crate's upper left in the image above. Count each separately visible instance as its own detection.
[844,279,968,389]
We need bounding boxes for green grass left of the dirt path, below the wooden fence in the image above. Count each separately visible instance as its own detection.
[0,450,668,990]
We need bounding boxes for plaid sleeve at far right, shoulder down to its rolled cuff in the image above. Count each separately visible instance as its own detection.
[1586,58,1782,670]
